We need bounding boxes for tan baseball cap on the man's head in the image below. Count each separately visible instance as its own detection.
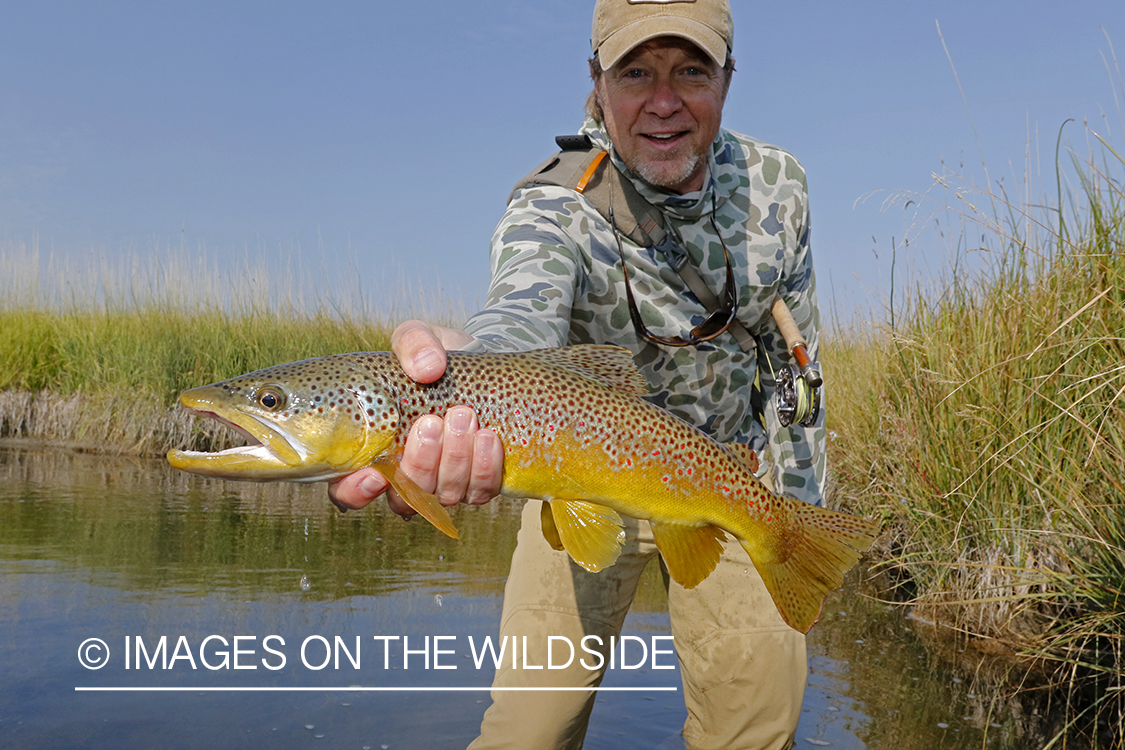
[590,0,735,70]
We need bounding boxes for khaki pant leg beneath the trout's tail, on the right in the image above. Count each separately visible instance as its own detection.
[668,541,808,750]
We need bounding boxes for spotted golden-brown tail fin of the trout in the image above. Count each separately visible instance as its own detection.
[739,500,878,633]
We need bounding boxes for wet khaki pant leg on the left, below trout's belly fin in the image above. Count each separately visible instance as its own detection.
[469,500,655,750]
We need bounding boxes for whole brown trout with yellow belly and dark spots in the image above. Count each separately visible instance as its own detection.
[168,345,876,632]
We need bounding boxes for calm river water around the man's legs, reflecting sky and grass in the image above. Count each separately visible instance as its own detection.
[0,446,1062,750]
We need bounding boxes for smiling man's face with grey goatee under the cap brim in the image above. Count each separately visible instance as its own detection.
[595,37,727,193]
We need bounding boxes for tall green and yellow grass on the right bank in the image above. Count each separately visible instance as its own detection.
[826,130,1125,737]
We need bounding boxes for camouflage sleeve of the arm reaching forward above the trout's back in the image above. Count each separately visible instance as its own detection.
[465,187,584,352]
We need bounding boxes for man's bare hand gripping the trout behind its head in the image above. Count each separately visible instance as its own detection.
[329,320,504,518]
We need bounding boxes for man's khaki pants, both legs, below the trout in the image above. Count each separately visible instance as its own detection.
[470,500,807,750]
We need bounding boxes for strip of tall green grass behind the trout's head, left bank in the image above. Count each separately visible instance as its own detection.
[0,243,459,453]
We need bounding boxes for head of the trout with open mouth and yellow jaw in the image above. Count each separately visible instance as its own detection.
[168,355,399,482]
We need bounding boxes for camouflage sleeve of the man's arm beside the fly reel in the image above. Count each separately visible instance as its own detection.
[758,164,827,505]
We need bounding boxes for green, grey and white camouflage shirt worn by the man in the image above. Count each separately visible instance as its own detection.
[465,119,825,504]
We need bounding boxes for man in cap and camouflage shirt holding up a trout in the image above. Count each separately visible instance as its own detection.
[330,0,825,749]
